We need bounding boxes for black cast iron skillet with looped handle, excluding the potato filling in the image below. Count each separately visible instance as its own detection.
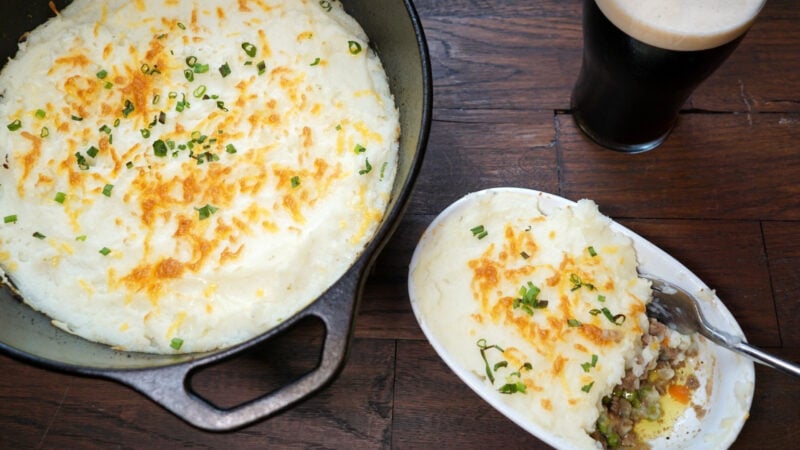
[0,0,433,431]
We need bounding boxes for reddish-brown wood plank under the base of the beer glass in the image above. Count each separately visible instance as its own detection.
[558,114,800,220]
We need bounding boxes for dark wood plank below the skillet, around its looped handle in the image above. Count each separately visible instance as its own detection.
[0,339,395,449]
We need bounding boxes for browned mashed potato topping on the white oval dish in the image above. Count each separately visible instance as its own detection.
[409,190,658,448]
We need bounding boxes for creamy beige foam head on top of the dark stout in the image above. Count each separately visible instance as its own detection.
[596,0,766,51]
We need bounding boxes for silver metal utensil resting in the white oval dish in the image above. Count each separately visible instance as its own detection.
[639,274,800,377]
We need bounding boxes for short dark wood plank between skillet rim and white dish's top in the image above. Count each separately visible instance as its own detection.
[409,110,558,214]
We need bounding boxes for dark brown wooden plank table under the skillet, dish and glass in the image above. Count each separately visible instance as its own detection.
[0,0,800,449]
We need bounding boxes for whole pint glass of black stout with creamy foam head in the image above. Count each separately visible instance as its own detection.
[572,0,766,153]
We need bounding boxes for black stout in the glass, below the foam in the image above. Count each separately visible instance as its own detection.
[572,0,764,153]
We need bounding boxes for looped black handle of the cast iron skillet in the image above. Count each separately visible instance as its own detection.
[99,261,364,431]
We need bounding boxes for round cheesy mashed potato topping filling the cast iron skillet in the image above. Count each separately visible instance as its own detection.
[0,0,399,352]
